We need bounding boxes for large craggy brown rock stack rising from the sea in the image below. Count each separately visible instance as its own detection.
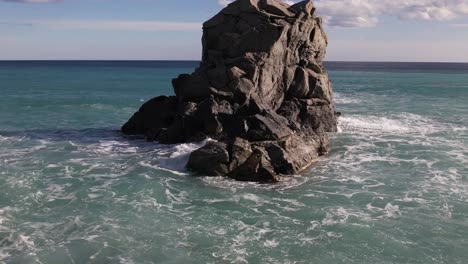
[122,0,337,182]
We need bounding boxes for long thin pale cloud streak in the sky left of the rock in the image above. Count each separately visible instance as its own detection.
[0,20,202,32]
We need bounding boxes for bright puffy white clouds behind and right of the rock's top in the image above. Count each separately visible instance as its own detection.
[218,0,468,27]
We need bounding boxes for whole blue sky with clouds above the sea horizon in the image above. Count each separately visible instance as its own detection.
[0,0,468,62]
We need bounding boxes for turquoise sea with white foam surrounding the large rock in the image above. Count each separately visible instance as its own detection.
[0,61,468,264]
